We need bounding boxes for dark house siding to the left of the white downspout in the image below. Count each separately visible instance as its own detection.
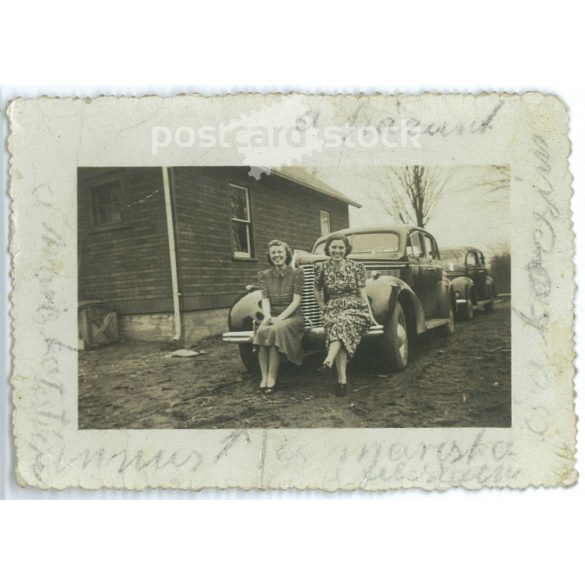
[77,167,172,314]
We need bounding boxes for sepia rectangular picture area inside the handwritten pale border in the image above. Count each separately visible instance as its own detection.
[77,165,512,429]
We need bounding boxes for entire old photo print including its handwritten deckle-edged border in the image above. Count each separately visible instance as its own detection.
[8,92,576,491]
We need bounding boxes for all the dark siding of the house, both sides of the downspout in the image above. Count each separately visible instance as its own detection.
[78,167,349,315]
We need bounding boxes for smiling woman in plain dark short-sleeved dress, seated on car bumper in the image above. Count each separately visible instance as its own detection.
[254,240,305,394]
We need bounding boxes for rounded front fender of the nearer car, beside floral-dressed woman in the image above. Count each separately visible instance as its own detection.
[366,276,425,333]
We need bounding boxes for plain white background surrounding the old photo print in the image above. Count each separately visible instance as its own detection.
[0,0,585,584]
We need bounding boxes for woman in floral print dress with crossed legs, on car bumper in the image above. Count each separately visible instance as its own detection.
[315,234,377,396]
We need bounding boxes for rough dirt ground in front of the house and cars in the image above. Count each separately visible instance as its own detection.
[79,299,511,429]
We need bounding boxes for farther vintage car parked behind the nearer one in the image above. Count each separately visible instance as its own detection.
[441,247,496,321]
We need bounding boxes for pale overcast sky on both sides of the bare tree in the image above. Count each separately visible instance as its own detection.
[317,166,510,255]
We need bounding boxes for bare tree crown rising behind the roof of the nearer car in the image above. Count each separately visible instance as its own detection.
[378,165,449,228]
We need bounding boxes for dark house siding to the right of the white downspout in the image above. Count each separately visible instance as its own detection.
[172,167,349,310]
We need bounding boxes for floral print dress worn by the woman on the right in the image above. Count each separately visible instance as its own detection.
[315,259,370,358]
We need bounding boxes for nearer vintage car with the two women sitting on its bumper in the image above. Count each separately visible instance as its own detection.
[223,226,456,371]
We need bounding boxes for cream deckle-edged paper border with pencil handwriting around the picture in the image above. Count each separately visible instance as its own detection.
[9,93,576,490]
